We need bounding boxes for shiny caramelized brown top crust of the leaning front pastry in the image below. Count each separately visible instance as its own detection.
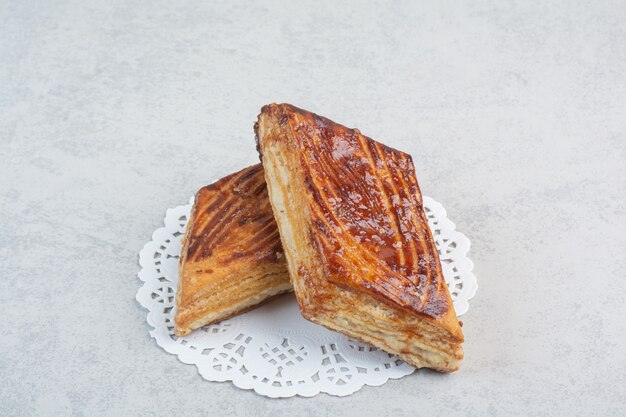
[257,104,450,322]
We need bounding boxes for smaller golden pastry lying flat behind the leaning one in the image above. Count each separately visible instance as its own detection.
[174,164,291,336]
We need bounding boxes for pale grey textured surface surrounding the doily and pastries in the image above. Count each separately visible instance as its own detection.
[0,0,626,417]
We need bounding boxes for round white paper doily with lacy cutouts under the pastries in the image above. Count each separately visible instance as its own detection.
[136,197,477,398]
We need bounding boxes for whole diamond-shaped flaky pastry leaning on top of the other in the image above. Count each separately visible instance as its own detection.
[255,104,463,372]
